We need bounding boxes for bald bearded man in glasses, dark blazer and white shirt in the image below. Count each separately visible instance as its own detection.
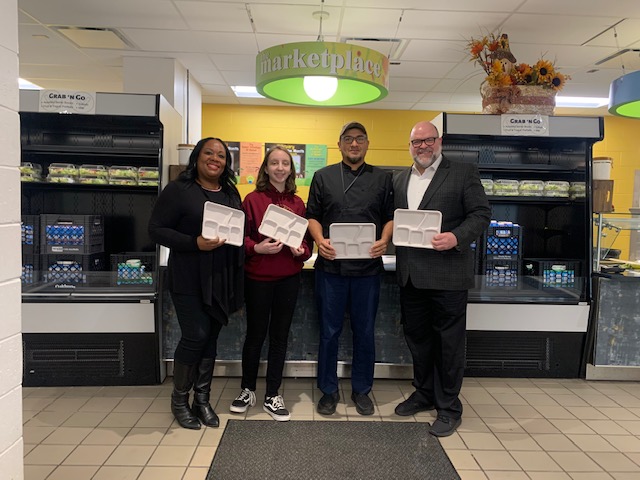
[393,122,491,437]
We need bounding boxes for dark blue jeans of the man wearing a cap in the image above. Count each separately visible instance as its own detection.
[315,270,380,394]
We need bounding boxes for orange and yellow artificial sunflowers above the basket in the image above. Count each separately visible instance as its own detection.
[468,33,570,91]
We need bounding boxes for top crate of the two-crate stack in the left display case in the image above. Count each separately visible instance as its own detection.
[40,214,104,255]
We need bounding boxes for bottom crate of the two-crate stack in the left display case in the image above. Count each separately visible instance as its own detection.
[41,253,105,284]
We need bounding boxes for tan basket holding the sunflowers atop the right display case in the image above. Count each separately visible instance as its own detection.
[480,83,557,115]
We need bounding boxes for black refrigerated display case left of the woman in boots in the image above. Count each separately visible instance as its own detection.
[20,91,181,386]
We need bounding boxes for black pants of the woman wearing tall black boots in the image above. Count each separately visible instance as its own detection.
[171,293,222,365]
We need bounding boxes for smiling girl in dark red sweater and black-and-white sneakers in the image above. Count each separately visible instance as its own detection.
[230,146,312,422]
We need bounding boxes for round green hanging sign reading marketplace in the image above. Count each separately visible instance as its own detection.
[256,42,389,107]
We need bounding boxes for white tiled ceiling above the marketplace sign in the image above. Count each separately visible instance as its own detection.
[18,0,640,115]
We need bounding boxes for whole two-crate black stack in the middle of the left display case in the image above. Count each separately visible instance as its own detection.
[40,214,105,286]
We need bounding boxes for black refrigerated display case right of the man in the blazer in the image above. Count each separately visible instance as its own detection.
[435,113,604,377]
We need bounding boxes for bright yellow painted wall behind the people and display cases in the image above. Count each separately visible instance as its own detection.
[202,104,640,255]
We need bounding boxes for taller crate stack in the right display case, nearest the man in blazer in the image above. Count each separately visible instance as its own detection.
[481,220,522,288]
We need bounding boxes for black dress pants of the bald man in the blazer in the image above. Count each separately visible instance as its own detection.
[400,279,468,418]
